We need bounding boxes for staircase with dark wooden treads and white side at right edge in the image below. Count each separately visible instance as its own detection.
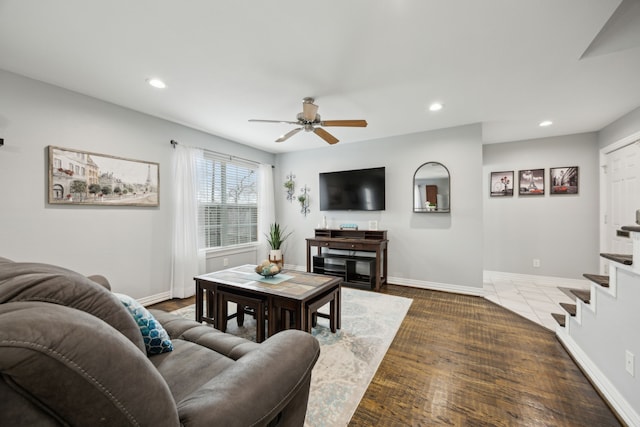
[552,226,640,426]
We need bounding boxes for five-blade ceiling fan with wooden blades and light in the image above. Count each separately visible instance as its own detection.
[249,97,367,144]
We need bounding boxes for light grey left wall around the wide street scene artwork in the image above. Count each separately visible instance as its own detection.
[0,71,274,298]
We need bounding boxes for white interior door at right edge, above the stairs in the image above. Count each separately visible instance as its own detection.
[605,141,640,254]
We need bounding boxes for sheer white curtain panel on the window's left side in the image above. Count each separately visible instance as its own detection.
[171,144,204,298]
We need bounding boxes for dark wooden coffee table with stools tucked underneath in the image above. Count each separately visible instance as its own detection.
[195,264,342,342]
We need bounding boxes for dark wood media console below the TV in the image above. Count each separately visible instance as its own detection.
[307,228,389,291]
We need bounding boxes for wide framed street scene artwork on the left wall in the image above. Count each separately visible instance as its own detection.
[48,146,160,207]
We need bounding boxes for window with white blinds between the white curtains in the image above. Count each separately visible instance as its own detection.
[197,151,258,248]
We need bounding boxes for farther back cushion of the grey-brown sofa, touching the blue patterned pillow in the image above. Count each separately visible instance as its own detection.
[0,262,145,352]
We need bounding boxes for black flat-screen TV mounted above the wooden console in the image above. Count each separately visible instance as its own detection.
[320,167,385,211]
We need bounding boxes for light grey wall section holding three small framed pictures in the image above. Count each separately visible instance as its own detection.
[482,133,599,279]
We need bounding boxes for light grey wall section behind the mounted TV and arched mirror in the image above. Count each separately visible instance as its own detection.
[274,125,482,293]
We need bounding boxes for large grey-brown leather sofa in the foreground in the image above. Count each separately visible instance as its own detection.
[0,258,320,426]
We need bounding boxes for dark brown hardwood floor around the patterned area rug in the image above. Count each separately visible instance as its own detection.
[149,285,621,426]
